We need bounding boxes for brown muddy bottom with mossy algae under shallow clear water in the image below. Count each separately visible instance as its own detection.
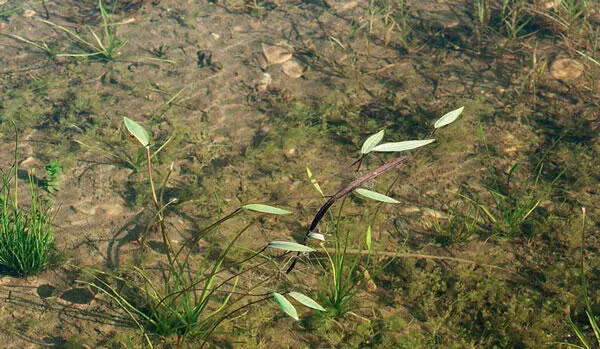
[0,0,600,348]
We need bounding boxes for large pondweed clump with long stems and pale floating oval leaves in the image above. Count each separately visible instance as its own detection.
[88,118,323,347]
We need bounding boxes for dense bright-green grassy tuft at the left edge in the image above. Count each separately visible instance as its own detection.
[0,130,54,276]
